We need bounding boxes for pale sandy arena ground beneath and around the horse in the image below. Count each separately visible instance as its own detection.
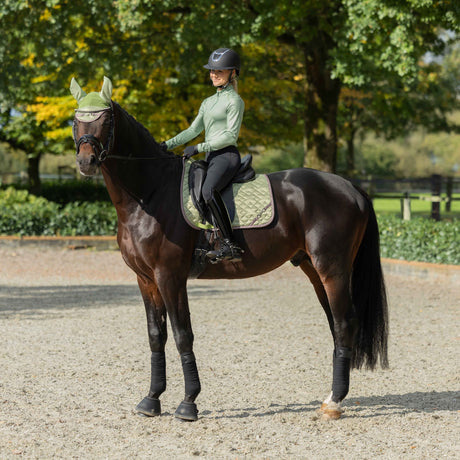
[0,247,460,460]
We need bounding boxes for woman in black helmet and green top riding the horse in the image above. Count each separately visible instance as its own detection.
[165,48,244,262]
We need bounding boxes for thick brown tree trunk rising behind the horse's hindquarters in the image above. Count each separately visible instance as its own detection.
[304,41,341,172]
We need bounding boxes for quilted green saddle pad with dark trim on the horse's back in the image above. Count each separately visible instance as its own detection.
[181,161,275,229]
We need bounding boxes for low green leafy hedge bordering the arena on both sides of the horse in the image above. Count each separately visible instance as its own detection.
[0,188,460,265]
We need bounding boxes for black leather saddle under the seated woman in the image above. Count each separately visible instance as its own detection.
[188,155,256,224]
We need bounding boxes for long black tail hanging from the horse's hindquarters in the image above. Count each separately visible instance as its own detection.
[351,188,388,369]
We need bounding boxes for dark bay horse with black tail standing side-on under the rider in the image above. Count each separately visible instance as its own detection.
[73,78,388,420]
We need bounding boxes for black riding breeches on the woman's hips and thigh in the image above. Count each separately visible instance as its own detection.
[201,145,241,202]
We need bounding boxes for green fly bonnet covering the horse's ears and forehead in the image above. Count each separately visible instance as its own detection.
[70,77,113,123]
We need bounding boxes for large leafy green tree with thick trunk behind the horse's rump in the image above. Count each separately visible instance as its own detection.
[117,0,460,171]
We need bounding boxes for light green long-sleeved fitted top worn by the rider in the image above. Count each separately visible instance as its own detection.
[166,85,244,152]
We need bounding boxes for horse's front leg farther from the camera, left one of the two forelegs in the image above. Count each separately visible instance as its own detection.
[136,276,167,417]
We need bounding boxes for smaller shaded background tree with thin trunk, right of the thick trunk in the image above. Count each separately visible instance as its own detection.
[338,51,460,175]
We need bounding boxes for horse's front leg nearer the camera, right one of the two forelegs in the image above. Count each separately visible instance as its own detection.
[160,275,201,421]
